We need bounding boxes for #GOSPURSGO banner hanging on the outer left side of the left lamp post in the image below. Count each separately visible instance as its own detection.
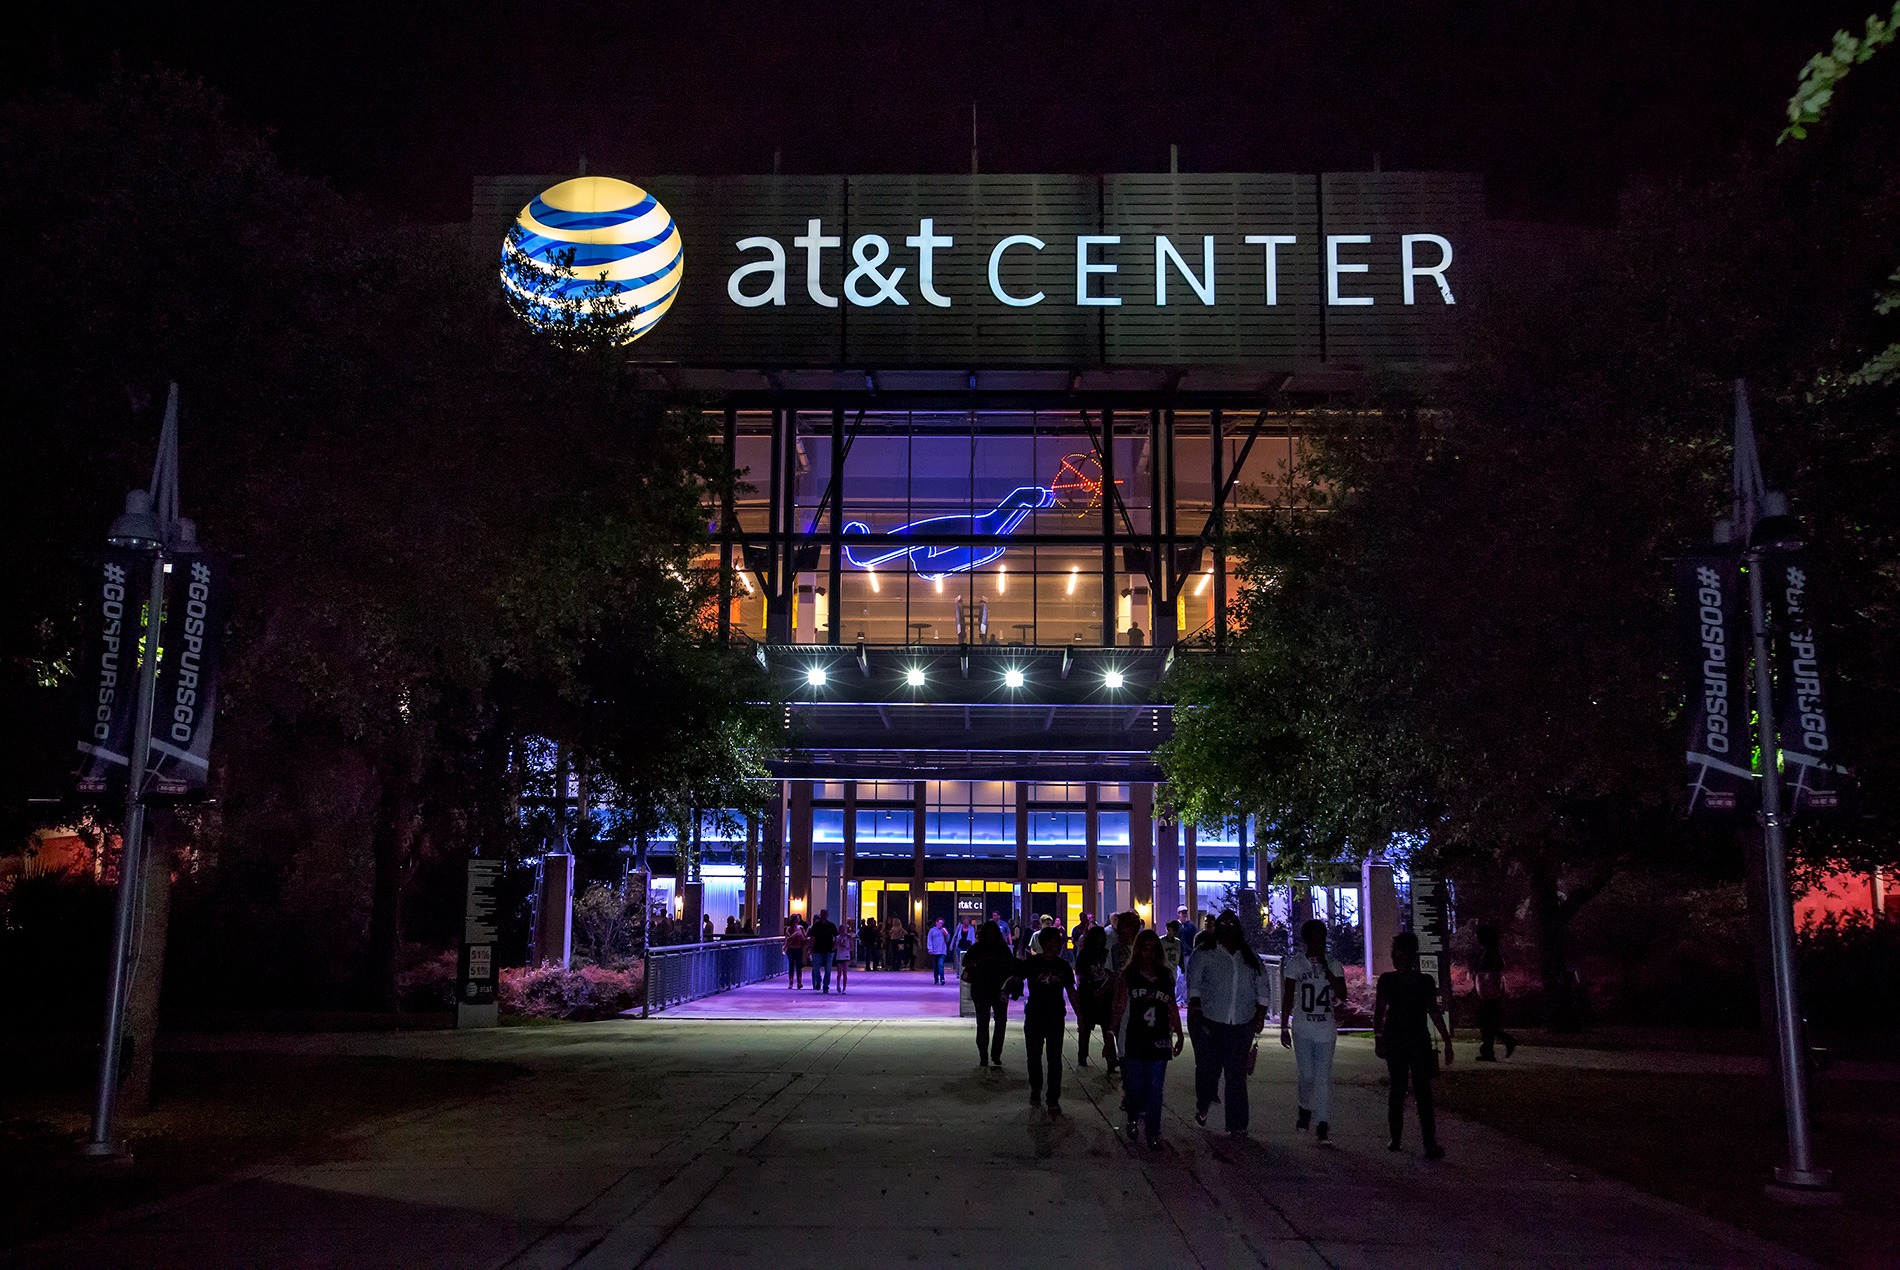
[74,551,152,795]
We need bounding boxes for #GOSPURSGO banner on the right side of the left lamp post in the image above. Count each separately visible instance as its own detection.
[146,553,230,799]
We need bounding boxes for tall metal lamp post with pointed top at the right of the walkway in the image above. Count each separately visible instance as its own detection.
[1716,380,1834,1192]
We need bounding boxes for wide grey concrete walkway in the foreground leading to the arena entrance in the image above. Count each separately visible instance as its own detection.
[7,1019,1799,1270]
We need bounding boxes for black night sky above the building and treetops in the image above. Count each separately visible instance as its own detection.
[0,0,1875,221]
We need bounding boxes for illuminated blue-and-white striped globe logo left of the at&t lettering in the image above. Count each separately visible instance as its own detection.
[502,177,686,344]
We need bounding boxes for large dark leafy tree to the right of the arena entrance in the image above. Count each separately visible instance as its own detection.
[1163,129,1900,1021]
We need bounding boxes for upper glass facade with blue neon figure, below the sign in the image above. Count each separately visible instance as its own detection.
[728,411,1300,646]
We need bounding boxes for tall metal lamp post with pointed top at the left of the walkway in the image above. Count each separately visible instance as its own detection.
[82,384,186,1158]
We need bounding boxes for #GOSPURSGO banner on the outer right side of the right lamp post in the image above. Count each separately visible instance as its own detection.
[1765,553,1847,816]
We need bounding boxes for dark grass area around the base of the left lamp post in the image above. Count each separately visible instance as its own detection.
[0,1046,519,1249]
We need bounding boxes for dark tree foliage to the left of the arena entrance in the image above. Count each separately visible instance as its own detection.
[0,74,771,1000]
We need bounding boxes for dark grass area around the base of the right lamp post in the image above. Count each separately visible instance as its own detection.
[1440,1065,1900,1266]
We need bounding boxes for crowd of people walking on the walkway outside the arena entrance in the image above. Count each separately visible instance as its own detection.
[785,909,1466,1160]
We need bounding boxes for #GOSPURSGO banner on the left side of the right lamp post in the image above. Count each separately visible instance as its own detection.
[1676,555,1754,816]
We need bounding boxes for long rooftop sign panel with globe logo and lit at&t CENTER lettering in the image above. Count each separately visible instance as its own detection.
[473,173,1484,369]
